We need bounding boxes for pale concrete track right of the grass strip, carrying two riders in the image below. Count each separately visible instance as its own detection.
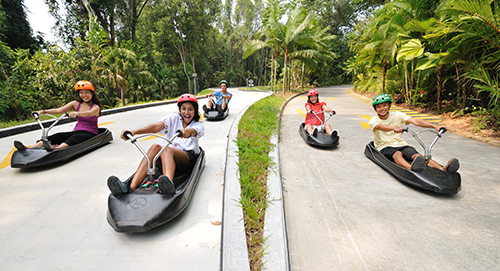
[279,85,500,270]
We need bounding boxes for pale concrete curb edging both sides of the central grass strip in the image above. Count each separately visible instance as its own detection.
[220,93,303,271]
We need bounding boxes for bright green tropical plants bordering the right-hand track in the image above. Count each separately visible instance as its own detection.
[348,0,500,128]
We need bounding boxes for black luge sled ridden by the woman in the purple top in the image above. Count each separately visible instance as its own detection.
[10,113,113,169]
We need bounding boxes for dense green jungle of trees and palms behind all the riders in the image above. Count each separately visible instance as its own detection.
[0,0,500,130]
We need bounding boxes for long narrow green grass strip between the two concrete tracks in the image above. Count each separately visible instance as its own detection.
[236,94,287,270]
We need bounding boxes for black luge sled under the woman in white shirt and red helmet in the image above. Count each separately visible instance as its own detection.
[107,132,205,233]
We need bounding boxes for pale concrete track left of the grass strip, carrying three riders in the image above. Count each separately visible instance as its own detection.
[0,88,270,270]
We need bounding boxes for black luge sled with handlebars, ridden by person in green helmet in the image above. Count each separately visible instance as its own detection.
[365,128,461,194]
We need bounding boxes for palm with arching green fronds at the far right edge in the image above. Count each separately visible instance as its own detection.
[438,0,500,113]
